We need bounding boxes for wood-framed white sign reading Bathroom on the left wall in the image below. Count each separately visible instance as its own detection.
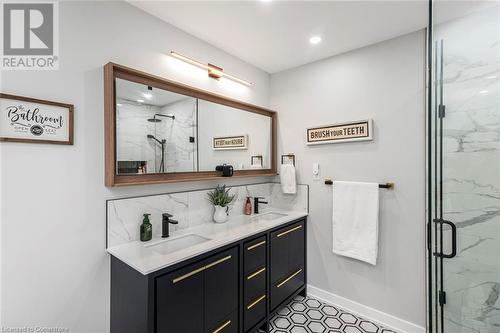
[0,93,73,145]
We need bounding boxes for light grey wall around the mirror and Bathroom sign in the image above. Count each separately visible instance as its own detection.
[0,1,269,333]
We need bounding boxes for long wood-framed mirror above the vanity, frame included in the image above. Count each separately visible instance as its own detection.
[104,63,277,186]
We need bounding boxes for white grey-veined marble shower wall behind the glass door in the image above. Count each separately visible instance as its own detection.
[436,6,500,333]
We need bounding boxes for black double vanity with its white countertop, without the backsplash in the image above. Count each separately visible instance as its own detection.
[108,212,307,333]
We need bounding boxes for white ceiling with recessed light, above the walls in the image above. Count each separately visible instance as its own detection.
[129,0,491,73]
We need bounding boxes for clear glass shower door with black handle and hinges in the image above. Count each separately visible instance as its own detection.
[428,4,500,333]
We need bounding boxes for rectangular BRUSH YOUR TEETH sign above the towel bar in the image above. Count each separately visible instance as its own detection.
[307,119,373,145]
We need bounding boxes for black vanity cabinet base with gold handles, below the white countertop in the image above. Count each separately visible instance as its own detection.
[111,218,306,333]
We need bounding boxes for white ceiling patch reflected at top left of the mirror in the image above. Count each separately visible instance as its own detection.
[116,79,189,107]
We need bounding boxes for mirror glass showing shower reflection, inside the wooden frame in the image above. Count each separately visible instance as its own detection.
[116,78,272,174]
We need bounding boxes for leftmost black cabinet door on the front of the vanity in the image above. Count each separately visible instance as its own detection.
[156,263,204,333]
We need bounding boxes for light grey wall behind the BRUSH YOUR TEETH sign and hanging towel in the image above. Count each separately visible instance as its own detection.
[271,31,425,326]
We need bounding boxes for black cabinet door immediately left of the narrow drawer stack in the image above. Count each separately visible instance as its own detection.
[203,248,239,333]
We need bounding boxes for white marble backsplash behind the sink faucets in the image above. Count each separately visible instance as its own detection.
[106,183,309,247]
